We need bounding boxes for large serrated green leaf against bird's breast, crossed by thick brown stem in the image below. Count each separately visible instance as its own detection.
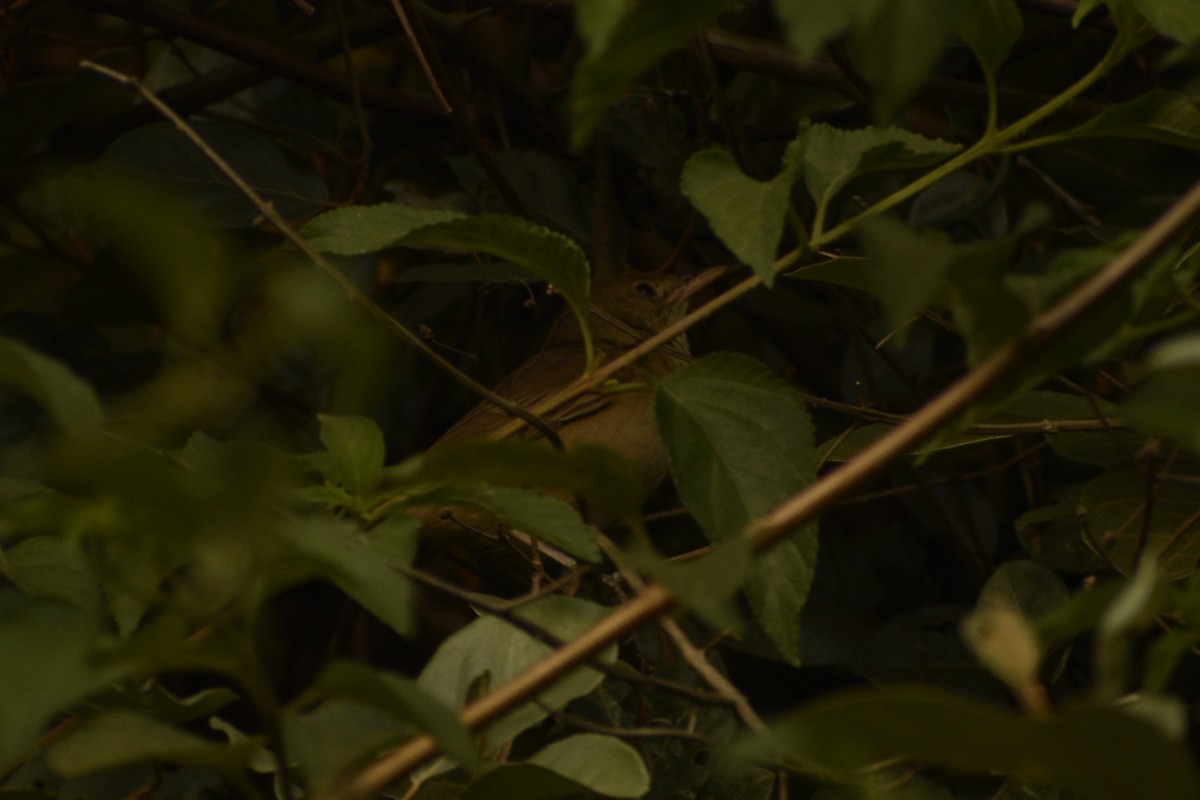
[654,354,817,661]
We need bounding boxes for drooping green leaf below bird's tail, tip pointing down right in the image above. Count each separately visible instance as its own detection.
[272,517,415,636]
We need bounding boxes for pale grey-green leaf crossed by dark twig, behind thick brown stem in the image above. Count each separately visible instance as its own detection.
[418,596,616,752]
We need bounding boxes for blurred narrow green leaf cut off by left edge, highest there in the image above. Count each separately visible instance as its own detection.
[0,336,104,435]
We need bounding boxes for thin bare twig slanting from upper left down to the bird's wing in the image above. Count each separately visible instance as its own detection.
[80,61,563,450]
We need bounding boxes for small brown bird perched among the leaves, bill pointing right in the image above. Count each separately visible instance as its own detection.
[419,267,724,582]
